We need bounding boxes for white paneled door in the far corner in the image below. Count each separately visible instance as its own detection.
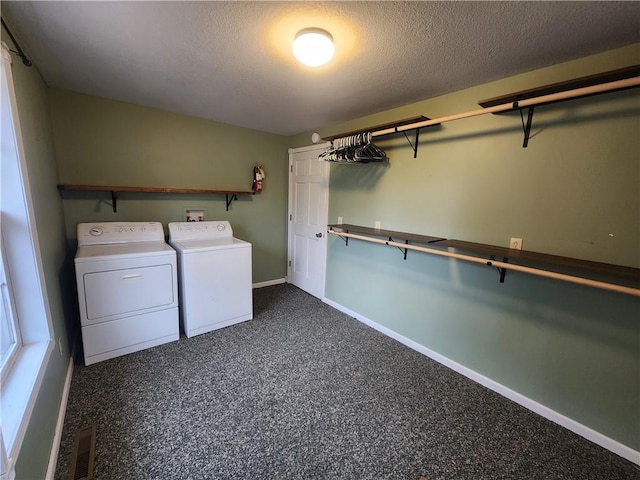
[288,144,329,298]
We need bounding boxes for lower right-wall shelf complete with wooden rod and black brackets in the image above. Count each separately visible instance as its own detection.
[328,224,640,296]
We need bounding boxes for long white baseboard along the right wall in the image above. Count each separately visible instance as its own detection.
[322,297,640,465]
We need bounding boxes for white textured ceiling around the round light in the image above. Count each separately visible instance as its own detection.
[1,1,640,135]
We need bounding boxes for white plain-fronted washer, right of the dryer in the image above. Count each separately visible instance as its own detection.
[169,221,253,337]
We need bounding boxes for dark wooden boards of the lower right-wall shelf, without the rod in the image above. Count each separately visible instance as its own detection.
[328,224,640,282]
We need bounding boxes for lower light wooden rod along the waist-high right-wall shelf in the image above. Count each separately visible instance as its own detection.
[329,230,640,297]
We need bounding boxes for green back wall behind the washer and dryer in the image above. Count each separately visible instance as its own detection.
[49,89,288,283]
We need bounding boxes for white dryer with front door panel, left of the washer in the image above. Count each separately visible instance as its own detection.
[75,222,180,365]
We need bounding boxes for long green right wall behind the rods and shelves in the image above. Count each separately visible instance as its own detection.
[291,45,640,450]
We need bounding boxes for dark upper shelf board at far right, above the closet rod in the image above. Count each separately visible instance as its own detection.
[478,65,640,108]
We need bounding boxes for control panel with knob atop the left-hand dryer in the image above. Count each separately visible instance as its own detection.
[78,222,164,245]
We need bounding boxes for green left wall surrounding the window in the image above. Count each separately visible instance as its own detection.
[2,30,75,480]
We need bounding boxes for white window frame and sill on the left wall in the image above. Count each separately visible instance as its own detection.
[0,42,54,479]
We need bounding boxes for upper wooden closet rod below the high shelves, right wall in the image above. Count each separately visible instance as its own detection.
[371,77,640,137]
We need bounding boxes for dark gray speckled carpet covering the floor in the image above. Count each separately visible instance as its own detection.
[55,285,640,480]
